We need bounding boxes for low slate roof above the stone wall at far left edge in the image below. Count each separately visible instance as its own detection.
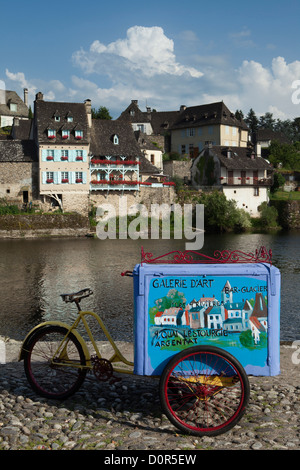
[0,140,38,163]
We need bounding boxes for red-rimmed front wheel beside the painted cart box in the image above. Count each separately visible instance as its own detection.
[159,346,250,436]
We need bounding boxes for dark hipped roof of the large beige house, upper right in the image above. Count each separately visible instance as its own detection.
[172,101,248,130]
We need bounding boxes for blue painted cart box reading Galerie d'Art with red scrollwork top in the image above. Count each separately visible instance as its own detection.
[133,248,280,376]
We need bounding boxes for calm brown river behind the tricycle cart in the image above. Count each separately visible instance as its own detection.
[0,233,300,341]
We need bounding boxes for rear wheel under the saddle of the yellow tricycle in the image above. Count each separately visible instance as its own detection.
[24,325,87,399]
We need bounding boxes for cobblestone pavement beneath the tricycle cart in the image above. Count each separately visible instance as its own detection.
[0,341,300,451]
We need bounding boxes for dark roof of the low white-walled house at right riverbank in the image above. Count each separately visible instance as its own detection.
[204,145,273,171]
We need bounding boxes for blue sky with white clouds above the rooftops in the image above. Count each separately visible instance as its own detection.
[0,0,300,120]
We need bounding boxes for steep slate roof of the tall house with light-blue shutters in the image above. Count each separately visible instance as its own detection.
[34,99,90,145]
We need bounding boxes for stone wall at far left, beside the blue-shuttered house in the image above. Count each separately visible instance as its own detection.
[0,162,38,204]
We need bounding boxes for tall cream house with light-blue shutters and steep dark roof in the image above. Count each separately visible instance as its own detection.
[33,93,92,213]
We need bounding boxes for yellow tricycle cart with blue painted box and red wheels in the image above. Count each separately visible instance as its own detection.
[20,247,280,436]
